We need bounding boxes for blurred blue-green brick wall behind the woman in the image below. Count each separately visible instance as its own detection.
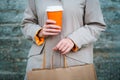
[0,0,120,80]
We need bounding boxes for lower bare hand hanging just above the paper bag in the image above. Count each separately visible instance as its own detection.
[53,38,74,54]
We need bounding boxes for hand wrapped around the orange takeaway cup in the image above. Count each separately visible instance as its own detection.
[38,20,61,37]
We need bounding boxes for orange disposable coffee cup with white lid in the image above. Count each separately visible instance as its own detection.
[46,6,63,28]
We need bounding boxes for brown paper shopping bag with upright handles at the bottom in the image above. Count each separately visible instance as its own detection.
[27,49,97,80]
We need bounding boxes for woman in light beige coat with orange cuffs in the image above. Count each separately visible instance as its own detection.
[22,0,106,79]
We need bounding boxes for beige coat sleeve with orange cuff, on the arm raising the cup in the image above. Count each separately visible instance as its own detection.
[22,0,44,44]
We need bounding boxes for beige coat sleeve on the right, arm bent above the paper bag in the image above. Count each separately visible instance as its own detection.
[68,0,106,50]
